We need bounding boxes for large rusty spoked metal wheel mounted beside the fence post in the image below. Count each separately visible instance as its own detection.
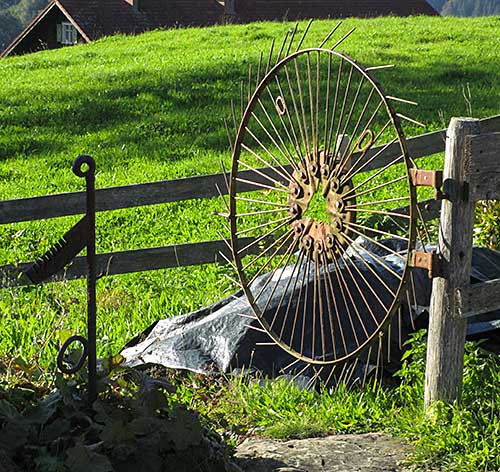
[229,48,416,365]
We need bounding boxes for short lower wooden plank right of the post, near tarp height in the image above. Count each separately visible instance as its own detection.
[455,279,500,318]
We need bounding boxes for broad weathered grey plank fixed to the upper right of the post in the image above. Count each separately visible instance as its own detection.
[466,133,500,201]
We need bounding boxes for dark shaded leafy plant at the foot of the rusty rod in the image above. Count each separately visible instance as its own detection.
[0,360,237,472]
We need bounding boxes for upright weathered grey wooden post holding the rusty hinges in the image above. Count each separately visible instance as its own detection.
[424,118,480,409]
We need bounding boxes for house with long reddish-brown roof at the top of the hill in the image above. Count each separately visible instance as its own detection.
[1,0,437,57]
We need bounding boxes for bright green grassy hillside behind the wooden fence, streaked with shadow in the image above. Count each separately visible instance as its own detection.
[0,17,500,363]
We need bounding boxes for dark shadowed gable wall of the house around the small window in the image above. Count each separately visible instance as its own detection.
[10,8,83,55]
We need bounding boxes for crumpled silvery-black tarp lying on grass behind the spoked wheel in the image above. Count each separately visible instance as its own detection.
[121,238,500,376]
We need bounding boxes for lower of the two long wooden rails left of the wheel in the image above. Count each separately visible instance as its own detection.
[0,238,254,288]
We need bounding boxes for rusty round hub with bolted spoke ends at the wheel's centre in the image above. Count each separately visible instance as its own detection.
[288,151,356,260]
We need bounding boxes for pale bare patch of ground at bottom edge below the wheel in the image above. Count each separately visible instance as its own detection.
[235,433,411,472]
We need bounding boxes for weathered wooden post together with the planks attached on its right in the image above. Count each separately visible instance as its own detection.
[425,118,500,409]
